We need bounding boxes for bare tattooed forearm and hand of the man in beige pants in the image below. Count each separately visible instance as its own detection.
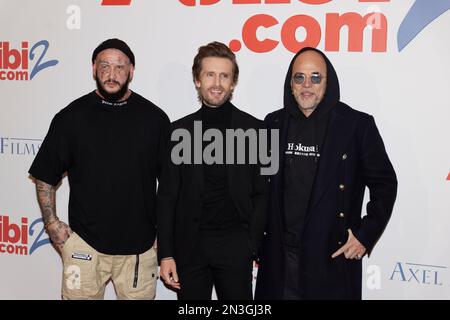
[36,179,72,252]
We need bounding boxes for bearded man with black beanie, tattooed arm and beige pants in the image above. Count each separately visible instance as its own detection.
[29,39,170,299]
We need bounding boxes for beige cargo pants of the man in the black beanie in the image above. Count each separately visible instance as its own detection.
[62,232,158,300]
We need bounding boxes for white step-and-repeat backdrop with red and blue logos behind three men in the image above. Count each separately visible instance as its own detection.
[0,0,450,299]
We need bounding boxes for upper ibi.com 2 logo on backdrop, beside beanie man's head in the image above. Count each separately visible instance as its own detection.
[0,40,58,81]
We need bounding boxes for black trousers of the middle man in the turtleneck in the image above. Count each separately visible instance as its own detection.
[177,229,253,300]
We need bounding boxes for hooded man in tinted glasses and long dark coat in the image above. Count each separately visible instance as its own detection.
[255,48,397,299]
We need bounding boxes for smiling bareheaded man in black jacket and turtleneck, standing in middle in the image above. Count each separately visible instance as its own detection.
[157,42,269,300]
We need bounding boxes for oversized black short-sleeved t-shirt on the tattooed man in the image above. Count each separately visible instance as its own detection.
[29,91,170,255]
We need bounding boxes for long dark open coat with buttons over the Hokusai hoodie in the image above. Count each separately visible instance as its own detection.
[255,102,397,299]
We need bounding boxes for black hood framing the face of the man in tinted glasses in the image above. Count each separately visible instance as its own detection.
[283,47,340,118]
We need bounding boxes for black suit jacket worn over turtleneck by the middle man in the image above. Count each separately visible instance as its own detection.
[157,106,269,266]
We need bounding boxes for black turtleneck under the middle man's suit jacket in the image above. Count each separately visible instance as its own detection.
[200,102,239,233]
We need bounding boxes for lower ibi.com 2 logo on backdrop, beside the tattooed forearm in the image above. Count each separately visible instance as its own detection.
[0,215,50,256]
